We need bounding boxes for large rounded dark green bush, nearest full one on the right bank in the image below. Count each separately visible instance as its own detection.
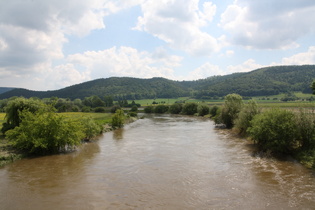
[248,109,297,154]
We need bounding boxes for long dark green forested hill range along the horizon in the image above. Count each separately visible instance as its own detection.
[0,65,315,100]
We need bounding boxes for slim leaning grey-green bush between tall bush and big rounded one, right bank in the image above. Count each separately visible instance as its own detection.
[235,100,260,135]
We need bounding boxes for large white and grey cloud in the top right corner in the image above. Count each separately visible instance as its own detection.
[220,0,315,49]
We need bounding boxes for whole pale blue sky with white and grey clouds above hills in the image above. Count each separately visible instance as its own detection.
[0,0,315,90]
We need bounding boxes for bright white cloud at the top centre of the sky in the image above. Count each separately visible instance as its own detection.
[135,0,219,56]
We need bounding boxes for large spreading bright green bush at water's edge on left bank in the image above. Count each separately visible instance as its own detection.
[6,110,84,154]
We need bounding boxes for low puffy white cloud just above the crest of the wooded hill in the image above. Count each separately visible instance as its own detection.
[68,47,182,78]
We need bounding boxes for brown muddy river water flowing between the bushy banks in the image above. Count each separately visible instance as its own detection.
[0,115,315,209]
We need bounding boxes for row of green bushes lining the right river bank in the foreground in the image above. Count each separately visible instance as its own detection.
[213,94,315,168]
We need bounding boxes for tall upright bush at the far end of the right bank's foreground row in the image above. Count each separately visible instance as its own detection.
[219,93,243,128]
